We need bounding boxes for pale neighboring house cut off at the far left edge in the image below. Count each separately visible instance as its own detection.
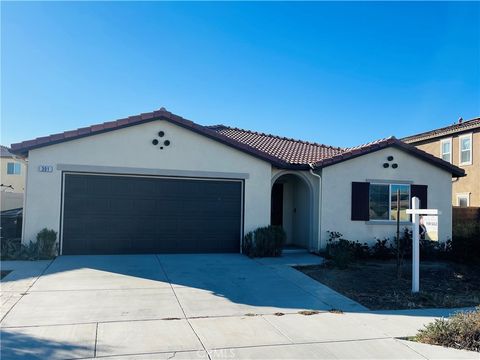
[0,145,27,211]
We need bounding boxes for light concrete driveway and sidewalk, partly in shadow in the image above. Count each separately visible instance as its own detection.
[1,254,479,359]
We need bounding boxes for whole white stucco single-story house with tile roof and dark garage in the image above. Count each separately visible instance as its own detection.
[12,108,464,254]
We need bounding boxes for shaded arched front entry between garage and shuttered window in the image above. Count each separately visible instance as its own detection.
[270,173,313,249]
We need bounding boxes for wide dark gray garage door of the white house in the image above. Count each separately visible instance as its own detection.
[62,174,242,255]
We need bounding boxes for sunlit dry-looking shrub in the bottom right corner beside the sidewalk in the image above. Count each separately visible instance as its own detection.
[415,307,480,351]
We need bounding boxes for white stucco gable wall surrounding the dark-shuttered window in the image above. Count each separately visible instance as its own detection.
[321,148,452,247]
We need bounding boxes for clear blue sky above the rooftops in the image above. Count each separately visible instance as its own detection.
[1,2,480,146]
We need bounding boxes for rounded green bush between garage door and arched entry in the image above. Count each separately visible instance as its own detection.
[243,225,287,257]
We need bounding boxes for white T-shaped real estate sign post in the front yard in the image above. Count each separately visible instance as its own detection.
[407,197,440,293]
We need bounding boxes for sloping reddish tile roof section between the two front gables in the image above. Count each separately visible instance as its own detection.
[207,125,343,165]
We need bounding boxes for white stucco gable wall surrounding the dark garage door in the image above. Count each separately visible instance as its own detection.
[23,120,271,246]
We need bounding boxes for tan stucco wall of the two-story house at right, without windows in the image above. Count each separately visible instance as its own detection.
[414,129,480,206]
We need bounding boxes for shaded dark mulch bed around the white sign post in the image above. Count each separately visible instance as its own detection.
[296,260,480,310]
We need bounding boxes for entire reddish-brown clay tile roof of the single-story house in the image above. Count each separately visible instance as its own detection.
[7,108,466,176]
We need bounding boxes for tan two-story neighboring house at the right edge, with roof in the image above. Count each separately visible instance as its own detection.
[402,118,480,207]
